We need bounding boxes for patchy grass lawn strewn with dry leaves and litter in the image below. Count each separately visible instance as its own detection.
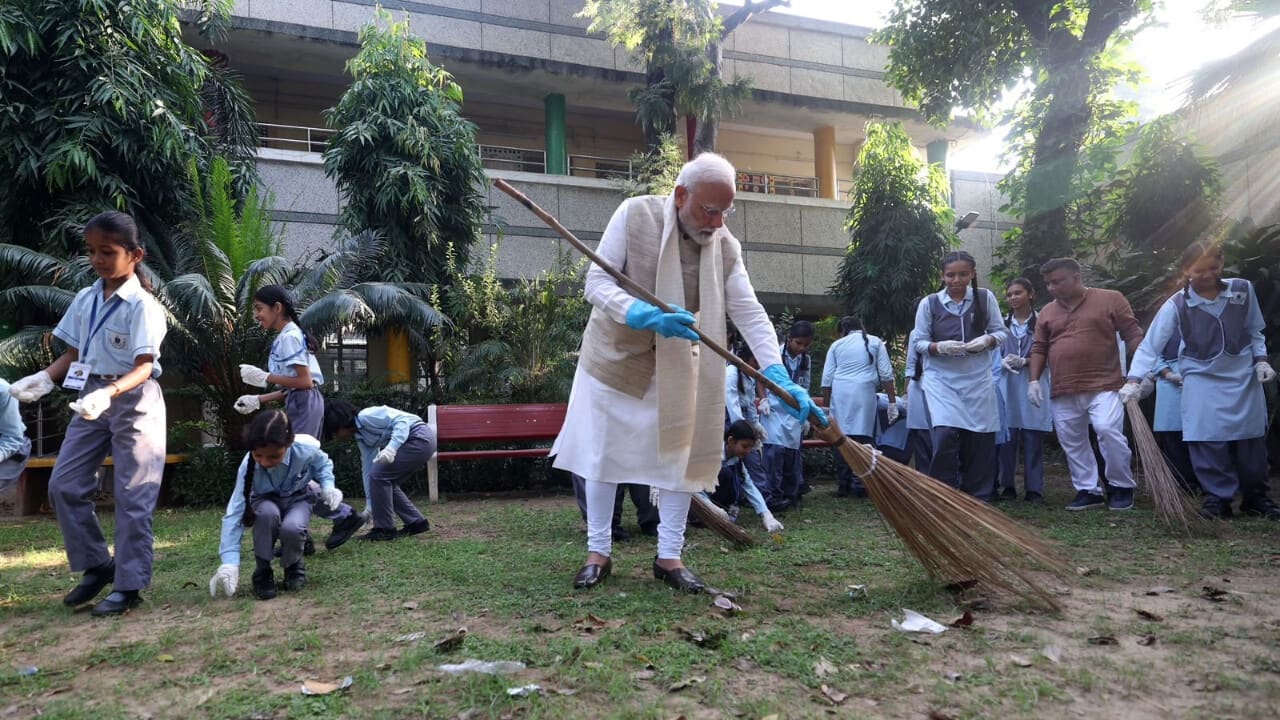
[0,477,1280,720]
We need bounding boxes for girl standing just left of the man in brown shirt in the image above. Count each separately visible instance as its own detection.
[996,278,1053,503]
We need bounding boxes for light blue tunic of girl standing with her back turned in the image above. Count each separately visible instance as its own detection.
[822,331,893,437]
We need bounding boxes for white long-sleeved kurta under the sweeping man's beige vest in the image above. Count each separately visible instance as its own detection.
[552,205,782,492]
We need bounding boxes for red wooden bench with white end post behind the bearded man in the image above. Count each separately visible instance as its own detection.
[426,402,827,502]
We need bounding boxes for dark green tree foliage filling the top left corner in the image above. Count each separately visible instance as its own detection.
[0,0,256,257]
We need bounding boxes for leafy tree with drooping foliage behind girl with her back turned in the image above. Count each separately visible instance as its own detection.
[827,123,956,343]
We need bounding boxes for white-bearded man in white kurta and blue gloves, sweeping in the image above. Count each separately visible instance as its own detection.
[552,152,826,593]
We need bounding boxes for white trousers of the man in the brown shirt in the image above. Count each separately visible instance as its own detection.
[1053,391,1134,495]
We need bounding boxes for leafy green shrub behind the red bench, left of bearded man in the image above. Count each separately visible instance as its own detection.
[435,246,591,402]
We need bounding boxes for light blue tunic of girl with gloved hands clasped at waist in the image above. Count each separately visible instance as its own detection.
[913,287,1009,433]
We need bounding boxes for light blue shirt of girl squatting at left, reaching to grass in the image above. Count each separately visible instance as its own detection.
[218,434,333,565]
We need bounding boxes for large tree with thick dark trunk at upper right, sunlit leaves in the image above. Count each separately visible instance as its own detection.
[876,0,1152,279]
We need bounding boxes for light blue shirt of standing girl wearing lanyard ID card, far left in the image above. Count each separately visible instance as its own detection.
[54,275,168,378]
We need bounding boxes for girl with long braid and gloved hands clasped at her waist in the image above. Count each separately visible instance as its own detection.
[914,251,1009,500]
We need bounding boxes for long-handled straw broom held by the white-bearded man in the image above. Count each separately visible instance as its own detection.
[494,179,1070,610]
